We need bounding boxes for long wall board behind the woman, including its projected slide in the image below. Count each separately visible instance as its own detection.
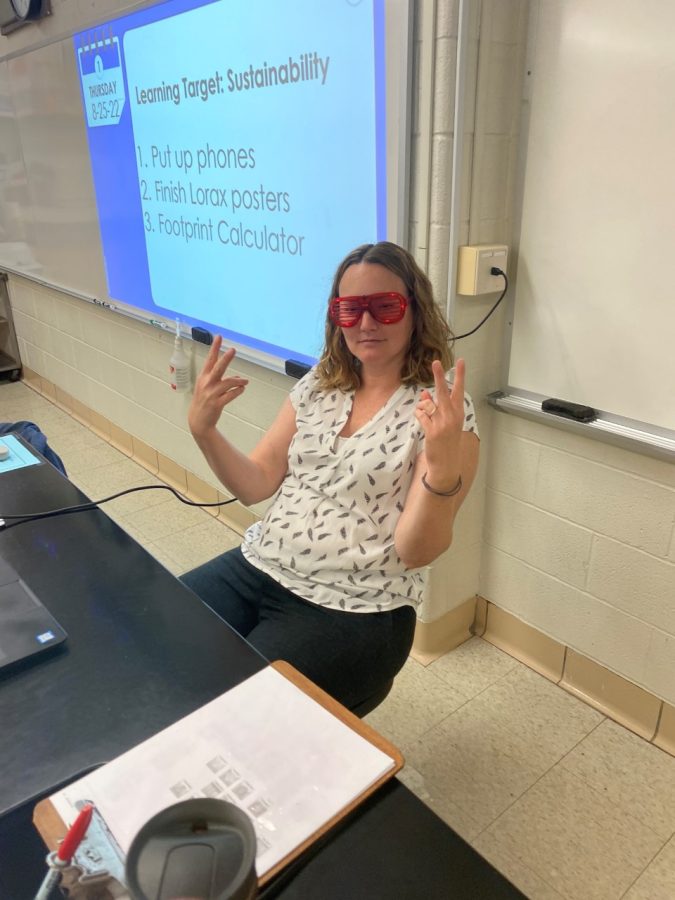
[0,0,411,372]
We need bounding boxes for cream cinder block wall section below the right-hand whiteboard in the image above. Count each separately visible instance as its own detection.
[480,413,675,703]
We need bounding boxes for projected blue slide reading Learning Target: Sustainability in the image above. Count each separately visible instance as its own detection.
[74,0,387,362]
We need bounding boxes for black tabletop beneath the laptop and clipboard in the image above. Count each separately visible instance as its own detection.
[0,442,523,900]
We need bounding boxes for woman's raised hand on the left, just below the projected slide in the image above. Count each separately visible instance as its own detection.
[188,334,248,438]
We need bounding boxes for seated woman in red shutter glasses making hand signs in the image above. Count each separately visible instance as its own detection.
[183,242,478,710]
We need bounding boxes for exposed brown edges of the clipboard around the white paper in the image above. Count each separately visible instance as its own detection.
[33,661,404,887]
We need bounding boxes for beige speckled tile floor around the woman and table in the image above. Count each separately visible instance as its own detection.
[0,384,675,900]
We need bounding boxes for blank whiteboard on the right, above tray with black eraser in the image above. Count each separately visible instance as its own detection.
[508,0,675,430]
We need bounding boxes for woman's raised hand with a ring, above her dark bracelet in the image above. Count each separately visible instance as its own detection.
[415,359,465,490]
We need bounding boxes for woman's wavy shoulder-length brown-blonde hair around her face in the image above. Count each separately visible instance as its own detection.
[316,241,453,391]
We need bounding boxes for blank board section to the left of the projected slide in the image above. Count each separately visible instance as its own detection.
[0,42,107,298]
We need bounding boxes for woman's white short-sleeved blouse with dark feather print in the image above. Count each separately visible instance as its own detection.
[241,369,478,612]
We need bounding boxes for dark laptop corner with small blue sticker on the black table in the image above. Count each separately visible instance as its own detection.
[0,556,68,672]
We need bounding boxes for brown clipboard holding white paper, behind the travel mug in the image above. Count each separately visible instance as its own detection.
[35,663,403,883]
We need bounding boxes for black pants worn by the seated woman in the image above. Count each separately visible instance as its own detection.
[181,548,416,709]
